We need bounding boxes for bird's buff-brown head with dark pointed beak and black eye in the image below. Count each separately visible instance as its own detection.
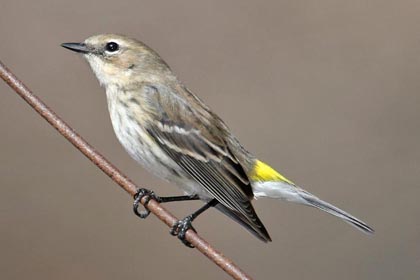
[61,34,171,87]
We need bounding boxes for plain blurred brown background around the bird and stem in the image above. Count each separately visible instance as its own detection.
[0,0,420,280]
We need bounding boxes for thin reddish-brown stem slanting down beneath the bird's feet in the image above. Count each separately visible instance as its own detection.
[0,61,251,279]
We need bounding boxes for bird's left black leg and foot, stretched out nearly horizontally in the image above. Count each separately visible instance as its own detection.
[133,188,200,219]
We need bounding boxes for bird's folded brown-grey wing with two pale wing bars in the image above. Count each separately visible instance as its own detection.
[146,83,270,241]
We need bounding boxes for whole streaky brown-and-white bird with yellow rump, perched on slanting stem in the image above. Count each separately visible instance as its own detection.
[62,34,373,246]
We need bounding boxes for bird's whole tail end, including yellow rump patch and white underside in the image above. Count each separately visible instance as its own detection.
[250,161,374,234]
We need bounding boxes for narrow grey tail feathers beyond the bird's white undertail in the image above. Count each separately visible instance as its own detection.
[298,191,375,234]
